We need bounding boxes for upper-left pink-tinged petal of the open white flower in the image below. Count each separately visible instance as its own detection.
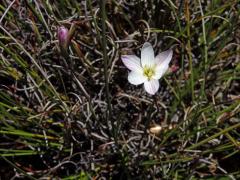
[121,55,142,73]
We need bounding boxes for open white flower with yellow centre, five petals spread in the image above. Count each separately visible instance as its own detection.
[121,42,173,95]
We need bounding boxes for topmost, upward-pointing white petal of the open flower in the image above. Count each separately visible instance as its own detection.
[141,42,155,67]
